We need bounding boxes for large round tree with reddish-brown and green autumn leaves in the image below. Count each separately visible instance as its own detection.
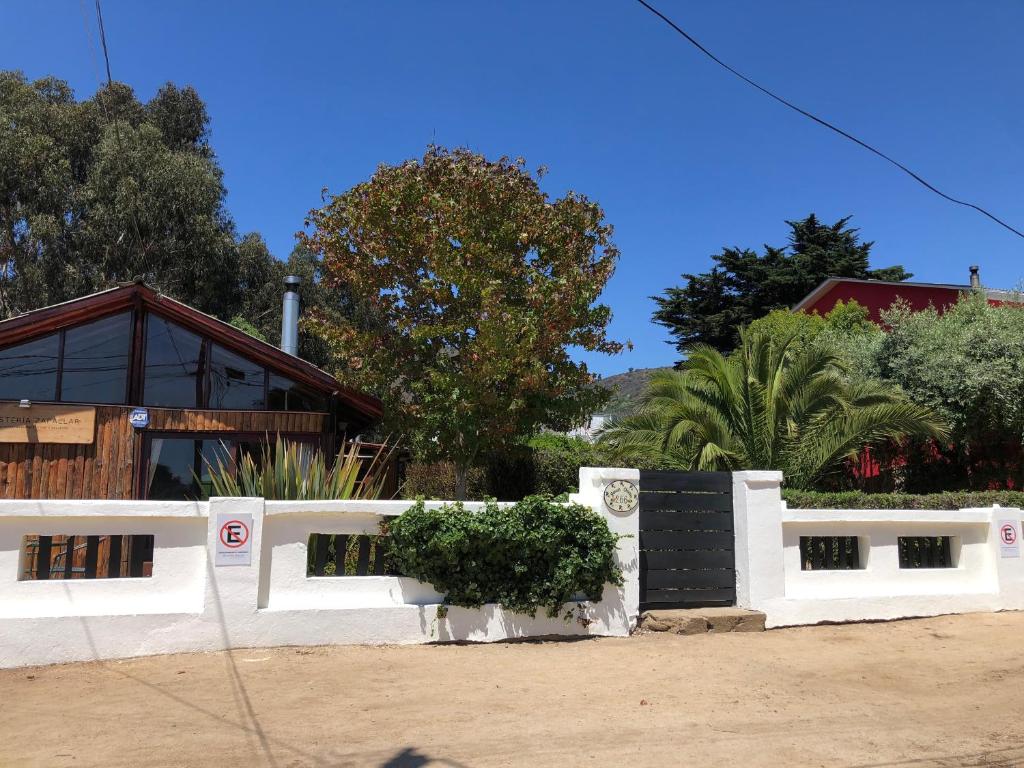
[303,146,622,498]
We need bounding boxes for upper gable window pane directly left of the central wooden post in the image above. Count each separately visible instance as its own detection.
[60,313,131,402]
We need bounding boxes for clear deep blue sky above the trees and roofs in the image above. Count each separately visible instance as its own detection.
[0,0,1024,375]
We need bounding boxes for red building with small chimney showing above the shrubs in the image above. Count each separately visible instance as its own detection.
[793,266,1019,323]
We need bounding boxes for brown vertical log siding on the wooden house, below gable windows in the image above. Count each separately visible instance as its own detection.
[0,406,328,499]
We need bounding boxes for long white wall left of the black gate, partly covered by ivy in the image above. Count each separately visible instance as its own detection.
[0,468,639,668]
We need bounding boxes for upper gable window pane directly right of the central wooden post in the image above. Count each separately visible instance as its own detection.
[143,313,203,408]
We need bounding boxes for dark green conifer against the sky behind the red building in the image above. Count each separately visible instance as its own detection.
[653,213,911,355]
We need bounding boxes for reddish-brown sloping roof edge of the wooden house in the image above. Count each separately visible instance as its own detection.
[0,283,383,419]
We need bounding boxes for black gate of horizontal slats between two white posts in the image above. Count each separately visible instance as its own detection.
[640,472,736,610]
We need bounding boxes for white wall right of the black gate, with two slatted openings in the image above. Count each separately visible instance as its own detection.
[732,472,1024,627]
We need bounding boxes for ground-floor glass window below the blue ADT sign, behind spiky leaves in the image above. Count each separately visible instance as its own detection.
[145,437,236,501]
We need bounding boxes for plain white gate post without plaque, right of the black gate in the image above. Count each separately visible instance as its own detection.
[732,471,785,610]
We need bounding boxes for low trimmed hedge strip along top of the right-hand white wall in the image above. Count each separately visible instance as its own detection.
[782,487,1024,509]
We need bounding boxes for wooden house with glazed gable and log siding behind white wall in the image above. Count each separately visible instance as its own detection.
[0,284,381,500]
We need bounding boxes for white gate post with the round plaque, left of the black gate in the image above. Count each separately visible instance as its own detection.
[569,467,640,632]
